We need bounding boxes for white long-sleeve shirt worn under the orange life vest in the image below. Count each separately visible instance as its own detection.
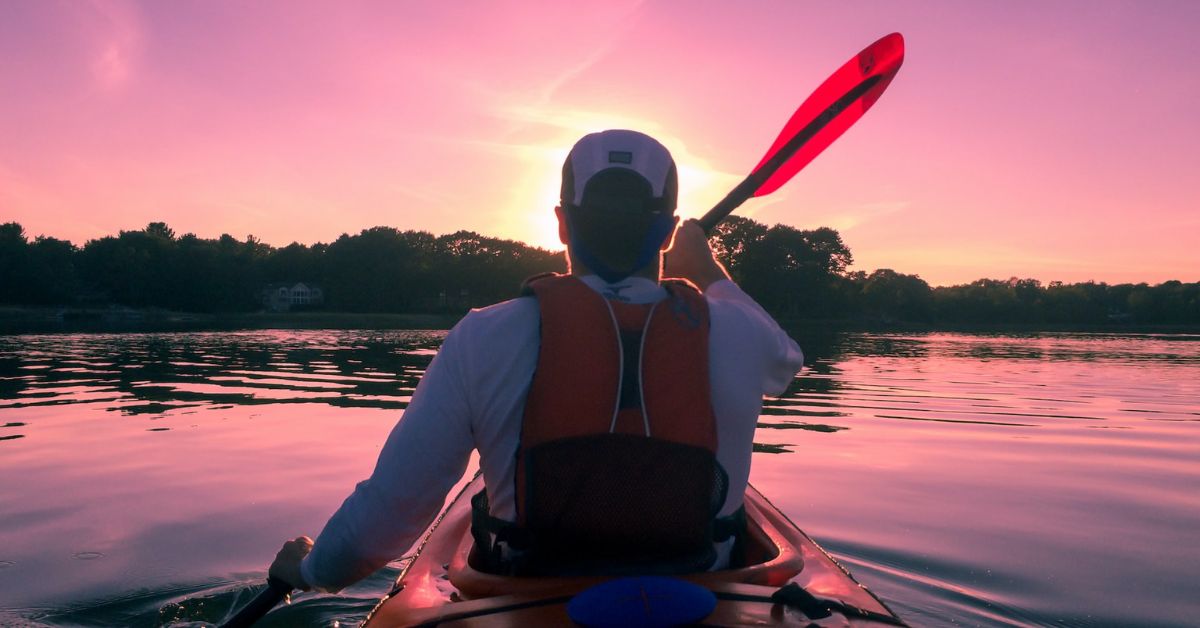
[301,275,804,592]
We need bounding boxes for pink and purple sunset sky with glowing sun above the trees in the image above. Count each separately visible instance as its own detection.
[0,0,1200,285]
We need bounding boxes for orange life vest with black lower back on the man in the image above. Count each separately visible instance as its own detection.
[468,275,728,574]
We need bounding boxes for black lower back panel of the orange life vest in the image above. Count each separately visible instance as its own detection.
[524,433,728,574]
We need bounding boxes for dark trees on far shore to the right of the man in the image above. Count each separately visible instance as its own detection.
[713,216,1200,325]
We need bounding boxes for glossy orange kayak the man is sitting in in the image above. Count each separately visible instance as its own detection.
[362,476,906,628]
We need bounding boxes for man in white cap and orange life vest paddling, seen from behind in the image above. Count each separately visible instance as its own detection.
[270,131,803,592]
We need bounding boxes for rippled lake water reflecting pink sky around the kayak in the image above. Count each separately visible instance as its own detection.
[0,330,1200,626]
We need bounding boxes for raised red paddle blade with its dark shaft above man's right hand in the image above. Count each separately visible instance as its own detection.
[700,32,904,233]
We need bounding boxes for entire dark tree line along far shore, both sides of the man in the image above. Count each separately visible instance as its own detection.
[0,216,1200,325]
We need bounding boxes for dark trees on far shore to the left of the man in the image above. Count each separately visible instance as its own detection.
[0,222,565,312]
